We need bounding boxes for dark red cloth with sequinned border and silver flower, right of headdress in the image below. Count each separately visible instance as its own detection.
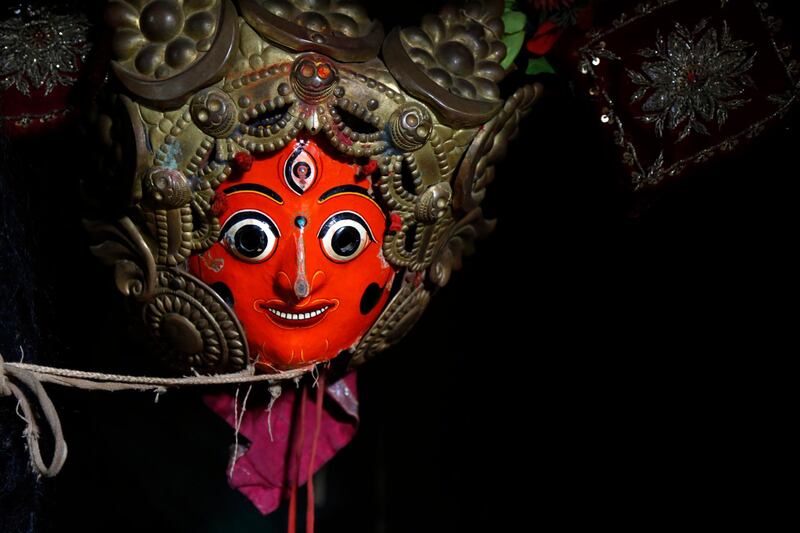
[578,0,799,189]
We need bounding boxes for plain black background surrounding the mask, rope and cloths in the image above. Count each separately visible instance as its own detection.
[0,3,800,533]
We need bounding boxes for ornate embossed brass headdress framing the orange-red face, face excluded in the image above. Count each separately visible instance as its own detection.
[90,0,539,372]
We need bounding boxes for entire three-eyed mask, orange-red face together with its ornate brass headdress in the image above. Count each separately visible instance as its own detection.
[90,0,540,372]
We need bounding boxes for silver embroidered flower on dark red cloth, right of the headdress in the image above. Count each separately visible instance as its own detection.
[627,19,756,142]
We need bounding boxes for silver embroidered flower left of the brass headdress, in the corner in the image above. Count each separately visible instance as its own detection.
[0,8,89,95]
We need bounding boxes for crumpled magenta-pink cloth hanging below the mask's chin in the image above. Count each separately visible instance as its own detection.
[204,372,358,514]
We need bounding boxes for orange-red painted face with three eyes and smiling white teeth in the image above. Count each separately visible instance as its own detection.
[189,139,394,369]
